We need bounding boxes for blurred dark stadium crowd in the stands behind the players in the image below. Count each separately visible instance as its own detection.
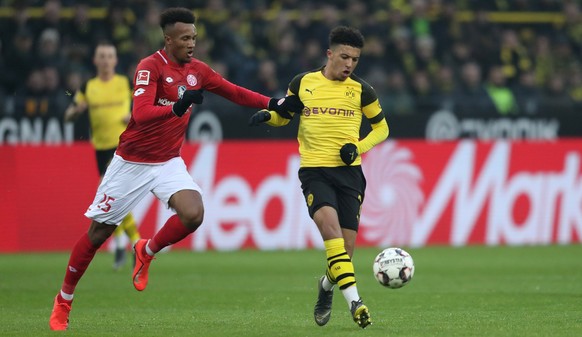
[0,0,582,118]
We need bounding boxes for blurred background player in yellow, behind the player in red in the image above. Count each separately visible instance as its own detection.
[65,43,140,270]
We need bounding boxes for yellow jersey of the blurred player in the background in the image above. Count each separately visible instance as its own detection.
[74,74,131,150]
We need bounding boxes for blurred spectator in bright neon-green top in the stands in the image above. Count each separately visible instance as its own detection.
[485,65,517,115]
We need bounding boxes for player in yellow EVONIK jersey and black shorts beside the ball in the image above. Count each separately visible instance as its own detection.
[249,26,388,328]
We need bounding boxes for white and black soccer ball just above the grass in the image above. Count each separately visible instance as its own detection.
[373,247,414,289]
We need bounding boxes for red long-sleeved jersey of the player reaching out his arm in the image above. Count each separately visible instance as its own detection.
[117,49,269,163]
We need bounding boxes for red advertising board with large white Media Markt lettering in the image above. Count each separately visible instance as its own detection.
[0,139,582,252]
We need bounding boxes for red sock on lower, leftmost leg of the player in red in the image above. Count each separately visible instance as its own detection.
[61,233,99,294]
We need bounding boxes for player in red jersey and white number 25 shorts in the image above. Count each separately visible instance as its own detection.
[49,8,303,330]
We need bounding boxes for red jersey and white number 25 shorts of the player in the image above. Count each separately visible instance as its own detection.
[85,49,269,225]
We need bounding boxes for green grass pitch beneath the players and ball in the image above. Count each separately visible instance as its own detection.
[0,245,582,337]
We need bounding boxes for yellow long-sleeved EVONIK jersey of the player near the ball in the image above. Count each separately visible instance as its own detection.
[267,68,388,167]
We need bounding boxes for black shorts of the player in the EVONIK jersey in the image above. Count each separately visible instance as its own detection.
[299,165,366,231]
